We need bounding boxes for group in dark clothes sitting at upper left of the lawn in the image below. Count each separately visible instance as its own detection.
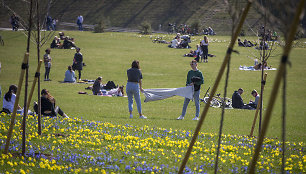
[50,32,76,49]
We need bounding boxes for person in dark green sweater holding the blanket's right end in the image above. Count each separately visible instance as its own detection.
[177,60,204,120]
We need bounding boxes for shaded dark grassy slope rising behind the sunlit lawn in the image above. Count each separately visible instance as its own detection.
[0,0,260,34]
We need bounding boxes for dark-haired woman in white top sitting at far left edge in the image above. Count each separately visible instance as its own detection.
[0,85,21,114]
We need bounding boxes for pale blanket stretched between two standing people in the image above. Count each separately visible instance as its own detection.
[143,86,193,102]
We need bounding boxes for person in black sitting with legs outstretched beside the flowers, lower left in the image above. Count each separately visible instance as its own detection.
[34,89,69,118]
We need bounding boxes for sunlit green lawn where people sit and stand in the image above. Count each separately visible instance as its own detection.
[0,31,306,142]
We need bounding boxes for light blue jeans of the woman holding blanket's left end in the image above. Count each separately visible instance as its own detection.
[126,82,142,114]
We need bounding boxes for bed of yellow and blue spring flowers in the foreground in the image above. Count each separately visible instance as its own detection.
[0,114,306,173]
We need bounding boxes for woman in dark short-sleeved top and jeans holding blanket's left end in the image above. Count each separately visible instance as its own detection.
[126,60,147,119]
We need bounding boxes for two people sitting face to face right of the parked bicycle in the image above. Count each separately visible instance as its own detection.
[232,88,260,110]
